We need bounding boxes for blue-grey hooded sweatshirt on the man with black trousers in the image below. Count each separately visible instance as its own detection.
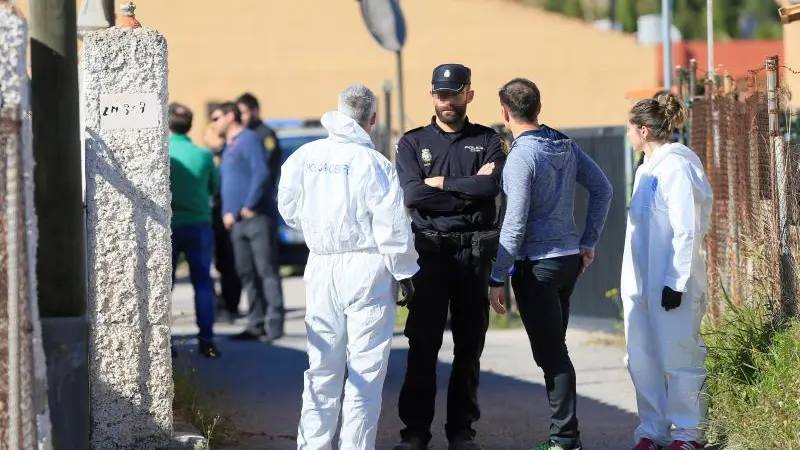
[492,125,612,281]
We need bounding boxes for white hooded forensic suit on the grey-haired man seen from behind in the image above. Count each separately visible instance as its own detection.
[278,112,419,450]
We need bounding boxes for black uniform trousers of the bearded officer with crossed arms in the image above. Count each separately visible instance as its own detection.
[398,236,490,443]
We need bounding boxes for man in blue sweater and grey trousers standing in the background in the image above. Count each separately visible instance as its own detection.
[211,102,284,343]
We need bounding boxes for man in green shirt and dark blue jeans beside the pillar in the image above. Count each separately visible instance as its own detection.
[169,103,220,358]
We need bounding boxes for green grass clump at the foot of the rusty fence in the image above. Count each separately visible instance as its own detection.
[704,296,800,450]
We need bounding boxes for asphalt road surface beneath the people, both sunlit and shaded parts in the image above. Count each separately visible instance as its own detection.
[173,278,636,450]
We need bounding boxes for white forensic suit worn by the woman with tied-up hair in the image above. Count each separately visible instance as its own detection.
[620,143,712,445]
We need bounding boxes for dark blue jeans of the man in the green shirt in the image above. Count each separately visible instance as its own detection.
[172,223,214,341]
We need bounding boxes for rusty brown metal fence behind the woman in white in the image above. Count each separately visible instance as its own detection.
[677,57,800,318]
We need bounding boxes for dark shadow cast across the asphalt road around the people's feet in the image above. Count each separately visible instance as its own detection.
[173,330,636,450]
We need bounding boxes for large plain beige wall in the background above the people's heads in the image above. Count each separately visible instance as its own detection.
[20,0,657,142]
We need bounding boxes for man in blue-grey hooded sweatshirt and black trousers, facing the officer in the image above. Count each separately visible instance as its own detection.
[489,78,612,450]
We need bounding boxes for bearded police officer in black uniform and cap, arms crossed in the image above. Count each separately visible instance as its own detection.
[394,64,505,450]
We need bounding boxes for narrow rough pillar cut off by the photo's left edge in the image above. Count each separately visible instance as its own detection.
[0,0,51,450]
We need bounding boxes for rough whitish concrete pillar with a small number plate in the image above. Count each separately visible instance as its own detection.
[83,4,173,449]
